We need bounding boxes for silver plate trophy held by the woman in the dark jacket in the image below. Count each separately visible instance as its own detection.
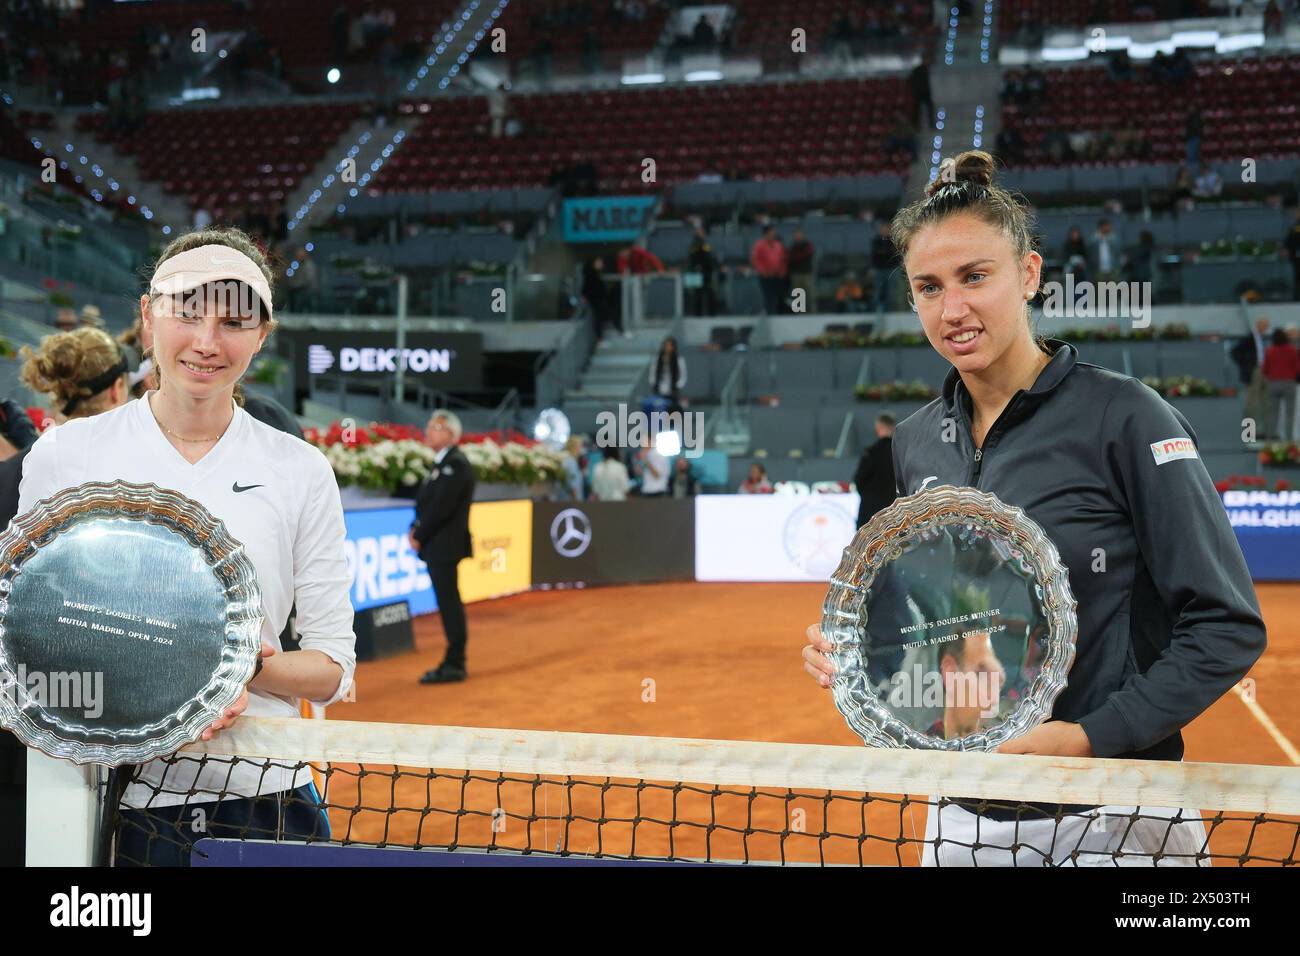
[822,485,1078,750]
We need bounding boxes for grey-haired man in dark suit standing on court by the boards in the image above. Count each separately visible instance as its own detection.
[411,411,475,684]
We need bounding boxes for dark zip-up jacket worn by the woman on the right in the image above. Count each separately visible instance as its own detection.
[893,341,1266,760]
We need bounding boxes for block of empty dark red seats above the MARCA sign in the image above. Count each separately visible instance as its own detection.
[374,78,911,193]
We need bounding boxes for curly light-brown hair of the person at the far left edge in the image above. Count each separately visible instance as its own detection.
[18,326,126,419]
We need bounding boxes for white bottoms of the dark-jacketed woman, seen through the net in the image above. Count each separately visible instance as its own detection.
[922,797,1209,866]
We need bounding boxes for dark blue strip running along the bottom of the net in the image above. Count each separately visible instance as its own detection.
[190,839,696,868]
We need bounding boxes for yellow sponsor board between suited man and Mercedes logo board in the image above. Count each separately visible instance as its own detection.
[460,498,533,604]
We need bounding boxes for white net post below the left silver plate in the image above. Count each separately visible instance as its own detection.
[27,748,99,866]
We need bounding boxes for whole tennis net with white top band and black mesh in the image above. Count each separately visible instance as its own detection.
[100,718,1300,866]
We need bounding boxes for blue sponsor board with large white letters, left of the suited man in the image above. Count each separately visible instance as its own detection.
[343,506,438,614]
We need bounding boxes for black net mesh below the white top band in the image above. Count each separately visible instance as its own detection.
[104,754,1300,866]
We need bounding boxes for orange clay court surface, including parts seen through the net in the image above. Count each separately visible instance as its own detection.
[317,583,1300,864]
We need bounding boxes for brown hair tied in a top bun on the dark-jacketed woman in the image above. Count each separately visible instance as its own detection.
[892,150,1037,264]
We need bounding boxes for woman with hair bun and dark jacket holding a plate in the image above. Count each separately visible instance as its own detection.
[803,151,1265,865]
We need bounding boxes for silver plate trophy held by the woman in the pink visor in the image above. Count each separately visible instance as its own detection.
[0,481,261,766]
